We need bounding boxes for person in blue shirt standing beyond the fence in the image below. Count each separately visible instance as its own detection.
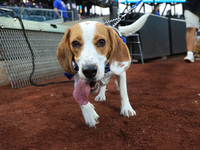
[53,0,68,22]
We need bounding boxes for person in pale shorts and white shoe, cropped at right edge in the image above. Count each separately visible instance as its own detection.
[184,0,200,62]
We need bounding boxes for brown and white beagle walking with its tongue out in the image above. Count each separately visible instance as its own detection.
[57,15,148,127]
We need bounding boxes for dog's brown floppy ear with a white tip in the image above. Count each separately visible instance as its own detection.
[108,27,131,75]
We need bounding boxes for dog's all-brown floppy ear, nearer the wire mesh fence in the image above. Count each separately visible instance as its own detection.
[57,28,76,75]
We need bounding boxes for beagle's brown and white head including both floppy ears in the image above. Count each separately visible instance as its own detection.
[57,21,130,82]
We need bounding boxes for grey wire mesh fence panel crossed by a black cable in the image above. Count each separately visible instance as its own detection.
[0,28,64,88]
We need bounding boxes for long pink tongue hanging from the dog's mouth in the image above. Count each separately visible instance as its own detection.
[73,78,90,105]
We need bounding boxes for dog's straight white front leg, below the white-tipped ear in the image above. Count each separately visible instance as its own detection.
[117,72,136,117]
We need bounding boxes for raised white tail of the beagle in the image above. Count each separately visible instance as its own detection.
[118,14,150,36]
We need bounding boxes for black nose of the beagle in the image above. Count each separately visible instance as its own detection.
[82,65,97,79]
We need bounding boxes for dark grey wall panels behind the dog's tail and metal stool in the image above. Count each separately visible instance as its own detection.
[120,13,186,59]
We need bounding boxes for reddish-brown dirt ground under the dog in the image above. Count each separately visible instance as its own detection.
[0,56,200,150]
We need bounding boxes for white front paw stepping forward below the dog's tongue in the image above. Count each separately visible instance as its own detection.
[80,102,99,127]
